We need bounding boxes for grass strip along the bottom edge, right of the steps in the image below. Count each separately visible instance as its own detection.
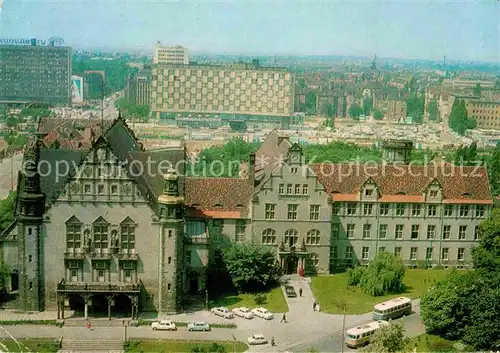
[125,340,248,353]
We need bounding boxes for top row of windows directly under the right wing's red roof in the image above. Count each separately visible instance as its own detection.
[332,202,486,218]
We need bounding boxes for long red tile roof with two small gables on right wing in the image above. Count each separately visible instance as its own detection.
[309,163,492,203]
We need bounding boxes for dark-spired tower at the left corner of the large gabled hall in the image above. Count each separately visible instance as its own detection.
[17,134,45,311]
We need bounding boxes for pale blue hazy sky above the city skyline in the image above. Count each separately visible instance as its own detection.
[0,0,500,62]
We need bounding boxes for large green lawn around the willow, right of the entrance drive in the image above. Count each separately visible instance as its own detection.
[311,269,450,314]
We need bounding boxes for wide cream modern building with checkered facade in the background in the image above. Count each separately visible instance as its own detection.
[152,65,294,117]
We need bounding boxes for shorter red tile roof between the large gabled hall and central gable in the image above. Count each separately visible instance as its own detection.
[184,177,253,218]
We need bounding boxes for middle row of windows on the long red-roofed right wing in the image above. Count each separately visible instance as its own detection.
[332,223,479,240]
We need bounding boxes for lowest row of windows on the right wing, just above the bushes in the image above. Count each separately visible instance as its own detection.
[331,246,465,261]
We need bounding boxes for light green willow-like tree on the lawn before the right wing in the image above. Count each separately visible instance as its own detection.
[348,251,405,296]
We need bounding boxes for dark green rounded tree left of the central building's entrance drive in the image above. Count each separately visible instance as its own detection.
[224,244,282,292]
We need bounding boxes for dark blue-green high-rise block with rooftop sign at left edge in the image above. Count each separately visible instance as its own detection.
[0,45,71,106]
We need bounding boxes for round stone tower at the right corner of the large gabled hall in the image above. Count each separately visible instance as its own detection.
[158,170,184,313]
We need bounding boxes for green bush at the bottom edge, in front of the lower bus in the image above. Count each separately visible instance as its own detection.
[363,322,411,353]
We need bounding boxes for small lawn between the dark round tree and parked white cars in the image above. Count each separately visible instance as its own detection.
[210,287,288,313]
